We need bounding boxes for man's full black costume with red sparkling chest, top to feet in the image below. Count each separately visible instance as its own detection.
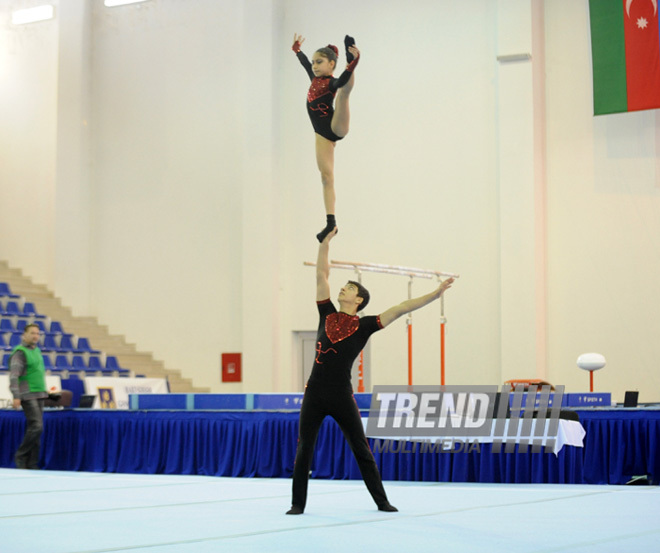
[287,299,397,514]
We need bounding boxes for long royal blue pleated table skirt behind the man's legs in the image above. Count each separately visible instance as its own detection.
[0,410,660,484]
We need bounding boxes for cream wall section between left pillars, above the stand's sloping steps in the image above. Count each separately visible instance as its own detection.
[91,0,244,385]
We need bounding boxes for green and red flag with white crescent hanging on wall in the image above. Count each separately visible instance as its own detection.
[589,0,660,115]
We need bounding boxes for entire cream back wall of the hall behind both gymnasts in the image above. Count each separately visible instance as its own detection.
[0,0,660,400]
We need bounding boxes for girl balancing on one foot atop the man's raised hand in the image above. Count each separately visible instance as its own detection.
[292,34,360,242]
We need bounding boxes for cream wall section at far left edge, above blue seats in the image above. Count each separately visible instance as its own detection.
[0,0,59,283]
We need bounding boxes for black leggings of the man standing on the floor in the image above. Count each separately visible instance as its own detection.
[292,384,388,510]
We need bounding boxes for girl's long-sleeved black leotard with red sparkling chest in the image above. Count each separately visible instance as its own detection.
[294,50,360,142]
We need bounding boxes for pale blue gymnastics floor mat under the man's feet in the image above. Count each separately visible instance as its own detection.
[0,469,660,553]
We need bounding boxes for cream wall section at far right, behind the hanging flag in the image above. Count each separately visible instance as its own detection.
[546,0,660,401]
